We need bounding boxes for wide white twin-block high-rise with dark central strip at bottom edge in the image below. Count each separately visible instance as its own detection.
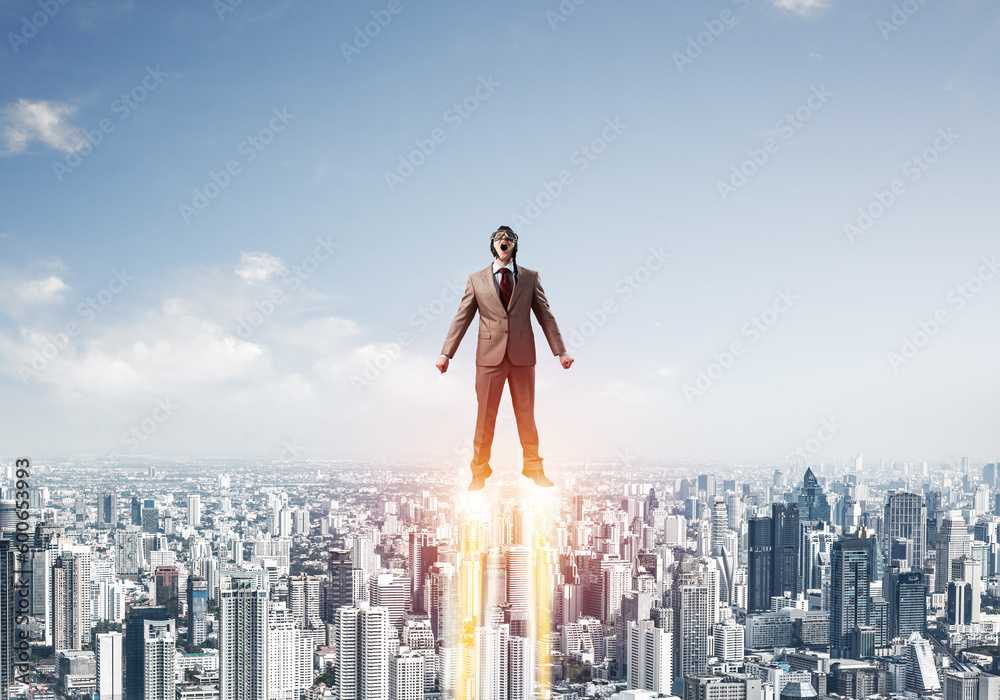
[333,602,392,700]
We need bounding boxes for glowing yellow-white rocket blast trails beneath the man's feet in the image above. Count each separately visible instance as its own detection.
[445,475,560,700]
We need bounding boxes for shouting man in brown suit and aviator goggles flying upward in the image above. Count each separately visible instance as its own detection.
[435,226,573,491]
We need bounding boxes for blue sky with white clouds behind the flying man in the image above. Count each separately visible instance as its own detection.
[0,0,1000,464]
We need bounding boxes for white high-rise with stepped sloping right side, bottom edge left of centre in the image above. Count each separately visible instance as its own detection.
[267,603,313,700]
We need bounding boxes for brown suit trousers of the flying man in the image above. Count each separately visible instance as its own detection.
[472,353,542,477]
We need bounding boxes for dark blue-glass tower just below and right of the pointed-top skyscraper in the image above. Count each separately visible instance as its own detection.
[830,538,870,658]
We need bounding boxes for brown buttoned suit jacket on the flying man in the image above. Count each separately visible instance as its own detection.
[441,265,566,367]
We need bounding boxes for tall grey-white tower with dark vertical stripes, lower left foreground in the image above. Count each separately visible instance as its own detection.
[218,570,268,700]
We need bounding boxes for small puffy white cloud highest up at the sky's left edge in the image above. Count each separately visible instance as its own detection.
[0,97,86,155]
